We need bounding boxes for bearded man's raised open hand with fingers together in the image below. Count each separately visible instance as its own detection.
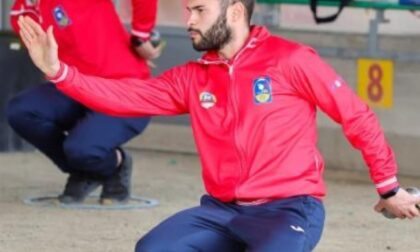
[18,16,60,76]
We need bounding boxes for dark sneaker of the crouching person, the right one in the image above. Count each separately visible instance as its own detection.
[100,149,133,205]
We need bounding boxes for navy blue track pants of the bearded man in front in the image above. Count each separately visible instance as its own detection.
[136,195,325,252]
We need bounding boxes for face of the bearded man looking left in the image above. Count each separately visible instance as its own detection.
[187,0,232,51]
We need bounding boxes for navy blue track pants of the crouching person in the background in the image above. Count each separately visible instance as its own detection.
[7,83,150,176]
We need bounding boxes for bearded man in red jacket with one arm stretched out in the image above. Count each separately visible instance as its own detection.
[15,0,420,252]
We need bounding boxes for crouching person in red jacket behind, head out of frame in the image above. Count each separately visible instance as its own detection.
[7,0,160,203]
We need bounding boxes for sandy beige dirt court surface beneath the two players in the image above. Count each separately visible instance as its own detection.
[0,150,420,252]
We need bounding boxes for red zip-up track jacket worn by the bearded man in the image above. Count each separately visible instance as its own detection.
[48,27,398,204]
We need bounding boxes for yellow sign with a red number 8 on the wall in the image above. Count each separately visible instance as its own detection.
[357,59,394,108]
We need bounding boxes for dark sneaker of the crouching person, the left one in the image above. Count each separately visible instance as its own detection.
[58,174,101,204]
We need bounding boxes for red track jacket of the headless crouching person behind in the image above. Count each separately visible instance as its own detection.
[10,0,157,79]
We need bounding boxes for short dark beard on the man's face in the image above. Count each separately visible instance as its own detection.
[188,14,232,52]
